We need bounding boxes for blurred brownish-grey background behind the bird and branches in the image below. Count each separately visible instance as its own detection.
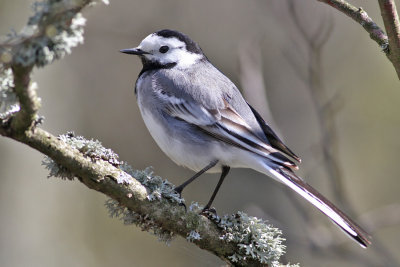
[0,0,400,266]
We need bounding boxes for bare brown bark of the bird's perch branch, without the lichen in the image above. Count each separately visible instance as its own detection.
[4,128,255,266]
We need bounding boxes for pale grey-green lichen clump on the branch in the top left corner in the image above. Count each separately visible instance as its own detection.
[0,0,108,67]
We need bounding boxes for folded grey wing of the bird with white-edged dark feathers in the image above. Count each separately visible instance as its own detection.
[154,80,297,168]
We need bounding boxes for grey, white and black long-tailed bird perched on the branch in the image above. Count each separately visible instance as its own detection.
[120,29,371,248]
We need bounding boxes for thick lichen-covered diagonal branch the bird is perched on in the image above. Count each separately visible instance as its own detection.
[0,116,290,266]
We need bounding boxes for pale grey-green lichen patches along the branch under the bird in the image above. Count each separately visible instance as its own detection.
[39,132,296,267]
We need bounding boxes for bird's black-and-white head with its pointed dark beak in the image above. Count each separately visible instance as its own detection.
[121,30,206,68]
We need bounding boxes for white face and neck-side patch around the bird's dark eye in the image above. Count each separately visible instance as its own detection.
[137,33,202,68]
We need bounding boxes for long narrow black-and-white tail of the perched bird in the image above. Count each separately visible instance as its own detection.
[266,166,371,248]
